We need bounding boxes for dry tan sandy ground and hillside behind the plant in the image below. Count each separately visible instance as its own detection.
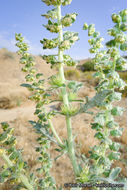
[0,49,127,190]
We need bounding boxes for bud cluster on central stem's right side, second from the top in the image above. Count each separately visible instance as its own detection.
[61,13,78,27]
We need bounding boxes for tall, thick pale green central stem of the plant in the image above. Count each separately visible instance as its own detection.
[57,5,80,176]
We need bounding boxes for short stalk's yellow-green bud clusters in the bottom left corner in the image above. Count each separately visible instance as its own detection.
[0,122,28,189]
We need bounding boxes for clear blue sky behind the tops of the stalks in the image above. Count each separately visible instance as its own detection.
[0,0,127,59]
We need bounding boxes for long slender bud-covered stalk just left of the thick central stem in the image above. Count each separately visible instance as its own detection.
[16,34,56,190]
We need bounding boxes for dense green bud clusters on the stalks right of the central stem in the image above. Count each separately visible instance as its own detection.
[83,10,127,183]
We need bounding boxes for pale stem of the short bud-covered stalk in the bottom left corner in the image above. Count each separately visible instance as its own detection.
[2,153,34,190]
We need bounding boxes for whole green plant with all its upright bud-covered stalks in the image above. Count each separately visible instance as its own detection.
[0,0,127,190]
